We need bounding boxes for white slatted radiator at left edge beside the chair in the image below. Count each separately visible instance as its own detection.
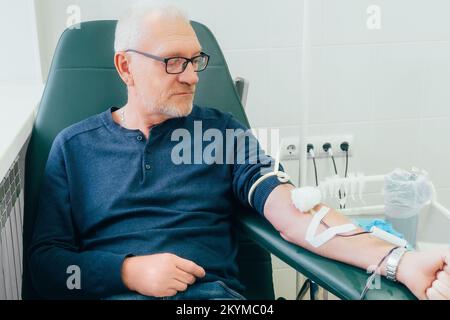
[0,157,23,300]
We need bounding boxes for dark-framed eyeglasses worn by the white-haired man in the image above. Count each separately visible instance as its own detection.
[125,49,209,74]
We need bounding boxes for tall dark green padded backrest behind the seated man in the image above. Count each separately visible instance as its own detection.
[22,21,273,299]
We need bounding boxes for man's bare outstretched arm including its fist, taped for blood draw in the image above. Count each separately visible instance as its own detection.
[264,184,450,299]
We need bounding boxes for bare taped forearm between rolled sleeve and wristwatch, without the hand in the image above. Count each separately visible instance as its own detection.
[264,184,394,275]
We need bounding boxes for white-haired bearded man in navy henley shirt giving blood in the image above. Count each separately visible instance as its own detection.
[30,6,450,299]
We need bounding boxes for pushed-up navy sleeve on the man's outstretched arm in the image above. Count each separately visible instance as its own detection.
[226,115,292,216]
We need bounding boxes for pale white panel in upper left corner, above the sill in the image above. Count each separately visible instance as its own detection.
[0,0,42,86]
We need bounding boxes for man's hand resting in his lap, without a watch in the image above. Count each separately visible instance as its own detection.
[122,253,205,297]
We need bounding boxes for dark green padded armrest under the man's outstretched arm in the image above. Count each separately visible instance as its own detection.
[238,211,416,300]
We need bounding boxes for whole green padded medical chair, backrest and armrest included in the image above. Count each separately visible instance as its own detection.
[22,21,413,299]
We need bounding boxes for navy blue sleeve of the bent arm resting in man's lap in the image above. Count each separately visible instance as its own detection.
[28,137,128,299]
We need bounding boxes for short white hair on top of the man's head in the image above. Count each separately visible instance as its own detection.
[114,0,189,52]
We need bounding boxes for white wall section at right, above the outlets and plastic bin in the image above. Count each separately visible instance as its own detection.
[309,0,450,207]
